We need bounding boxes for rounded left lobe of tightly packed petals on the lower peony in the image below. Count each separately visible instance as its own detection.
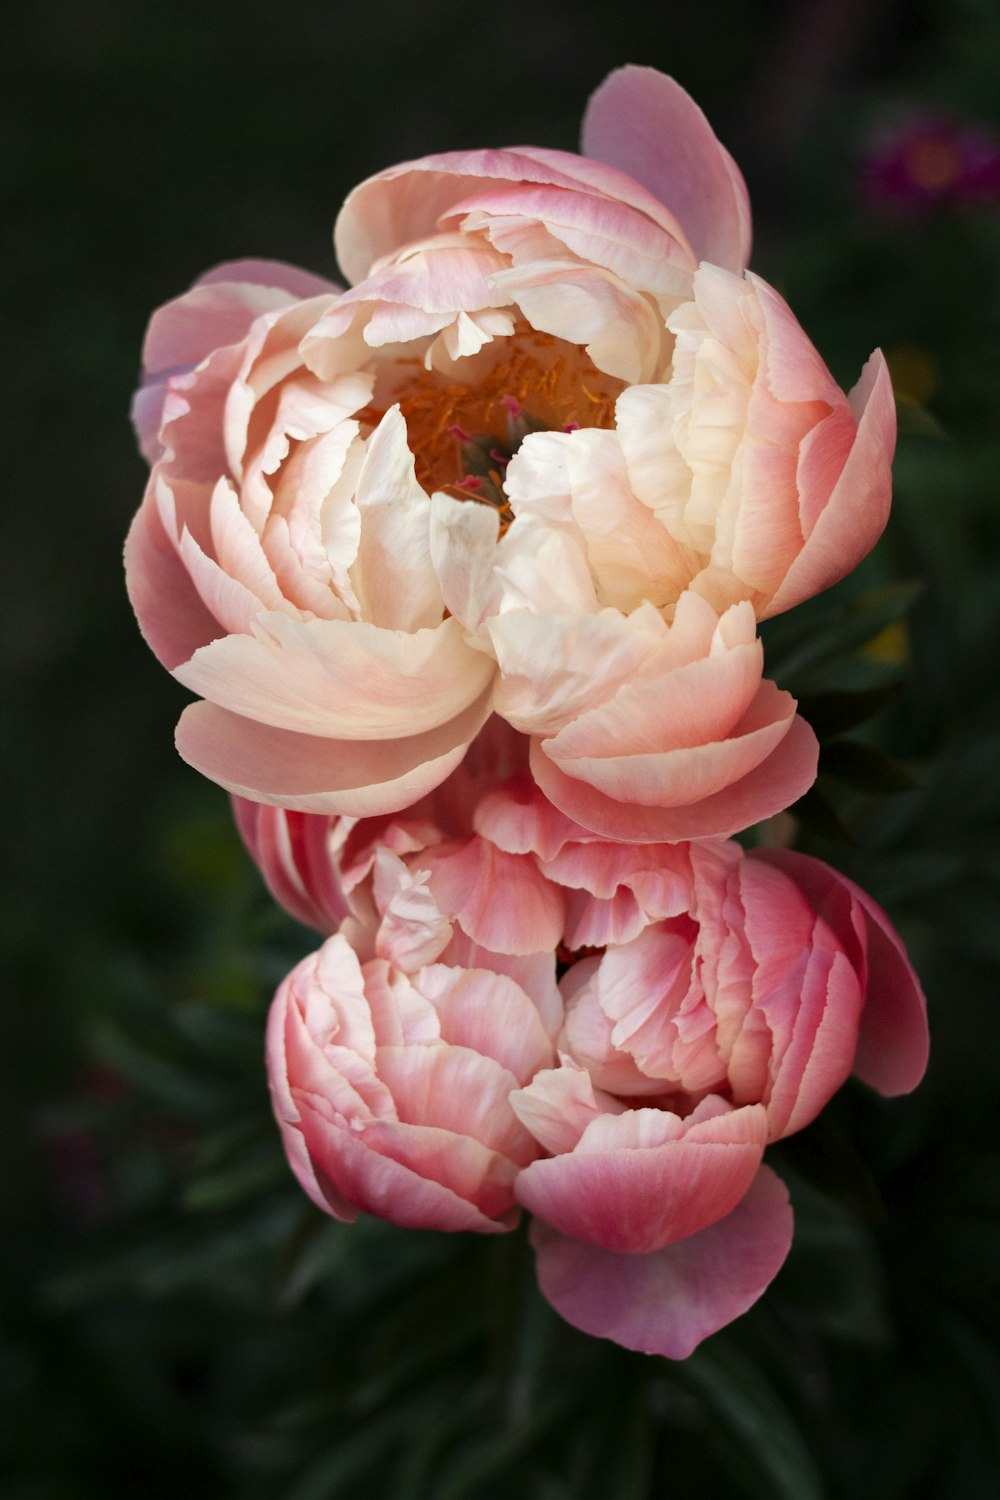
[267,848,553,1233]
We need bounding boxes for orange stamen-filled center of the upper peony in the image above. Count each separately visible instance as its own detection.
[358,324,625,534]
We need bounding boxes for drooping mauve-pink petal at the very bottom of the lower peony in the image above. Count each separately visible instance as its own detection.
[531,1167,793,1359]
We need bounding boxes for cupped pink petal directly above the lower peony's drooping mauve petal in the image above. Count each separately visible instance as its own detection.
[516,1104,768,1254]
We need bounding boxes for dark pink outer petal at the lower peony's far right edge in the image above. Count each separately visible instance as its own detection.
[751,849,930,1098]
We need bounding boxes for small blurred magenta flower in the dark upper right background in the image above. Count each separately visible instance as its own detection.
[862,113,1000,213]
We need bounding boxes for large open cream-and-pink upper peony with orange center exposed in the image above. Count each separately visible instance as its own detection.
[126,68,892,839]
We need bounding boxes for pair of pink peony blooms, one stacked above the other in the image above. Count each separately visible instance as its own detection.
[126,68,927,1358]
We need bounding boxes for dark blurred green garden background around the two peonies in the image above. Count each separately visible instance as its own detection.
[0,0,1000,1500]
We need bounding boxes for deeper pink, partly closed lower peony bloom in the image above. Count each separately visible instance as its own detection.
[262,771,927,1358]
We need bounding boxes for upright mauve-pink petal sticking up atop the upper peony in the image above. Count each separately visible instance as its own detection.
[582,66,750,272]
